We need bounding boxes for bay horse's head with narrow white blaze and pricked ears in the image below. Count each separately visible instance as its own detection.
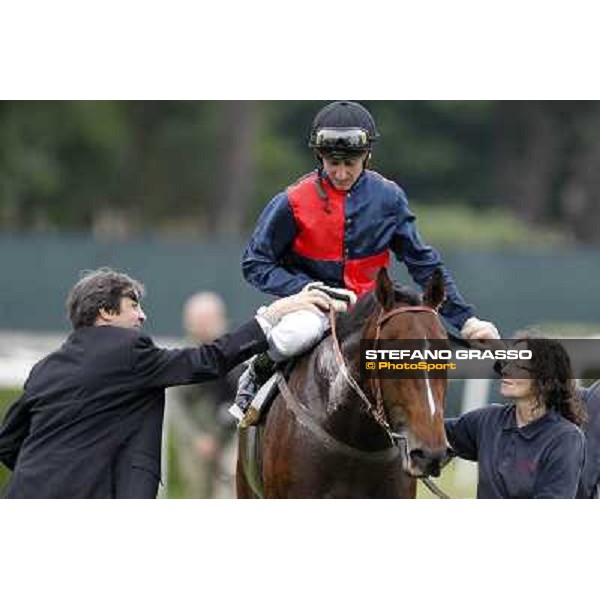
[369,269,448,477]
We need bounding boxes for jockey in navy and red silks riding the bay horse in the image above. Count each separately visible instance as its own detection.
[236,101,499,420]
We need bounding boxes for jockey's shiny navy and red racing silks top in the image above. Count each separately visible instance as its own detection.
[242,170,475,330]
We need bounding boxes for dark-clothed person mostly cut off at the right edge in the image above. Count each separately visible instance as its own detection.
[577,381,600,499]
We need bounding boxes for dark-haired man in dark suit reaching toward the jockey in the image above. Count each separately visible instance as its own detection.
[0,269,329,498]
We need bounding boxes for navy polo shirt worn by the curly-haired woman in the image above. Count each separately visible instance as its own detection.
[446,404,585,498]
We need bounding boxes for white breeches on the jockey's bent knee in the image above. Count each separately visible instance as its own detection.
[269,310,329,362]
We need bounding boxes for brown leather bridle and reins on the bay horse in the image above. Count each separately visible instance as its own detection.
[329,304,449,499]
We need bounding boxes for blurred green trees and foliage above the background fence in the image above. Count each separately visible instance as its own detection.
[0,101,600,246]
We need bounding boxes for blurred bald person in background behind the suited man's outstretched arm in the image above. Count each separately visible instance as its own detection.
[169,291,239,498]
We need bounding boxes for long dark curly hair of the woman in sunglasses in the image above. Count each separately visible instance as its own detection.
[519,334,587,426]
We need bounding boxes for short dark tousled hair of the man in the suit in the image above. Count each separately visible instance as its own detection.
[67,267,145,329]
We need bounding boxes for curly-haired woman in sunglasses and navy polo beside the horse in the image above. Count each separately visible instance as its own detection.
[446,337,585,498]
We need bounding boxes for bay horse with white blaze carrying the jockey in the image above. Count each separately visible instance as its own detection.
[236,269,448,498]
